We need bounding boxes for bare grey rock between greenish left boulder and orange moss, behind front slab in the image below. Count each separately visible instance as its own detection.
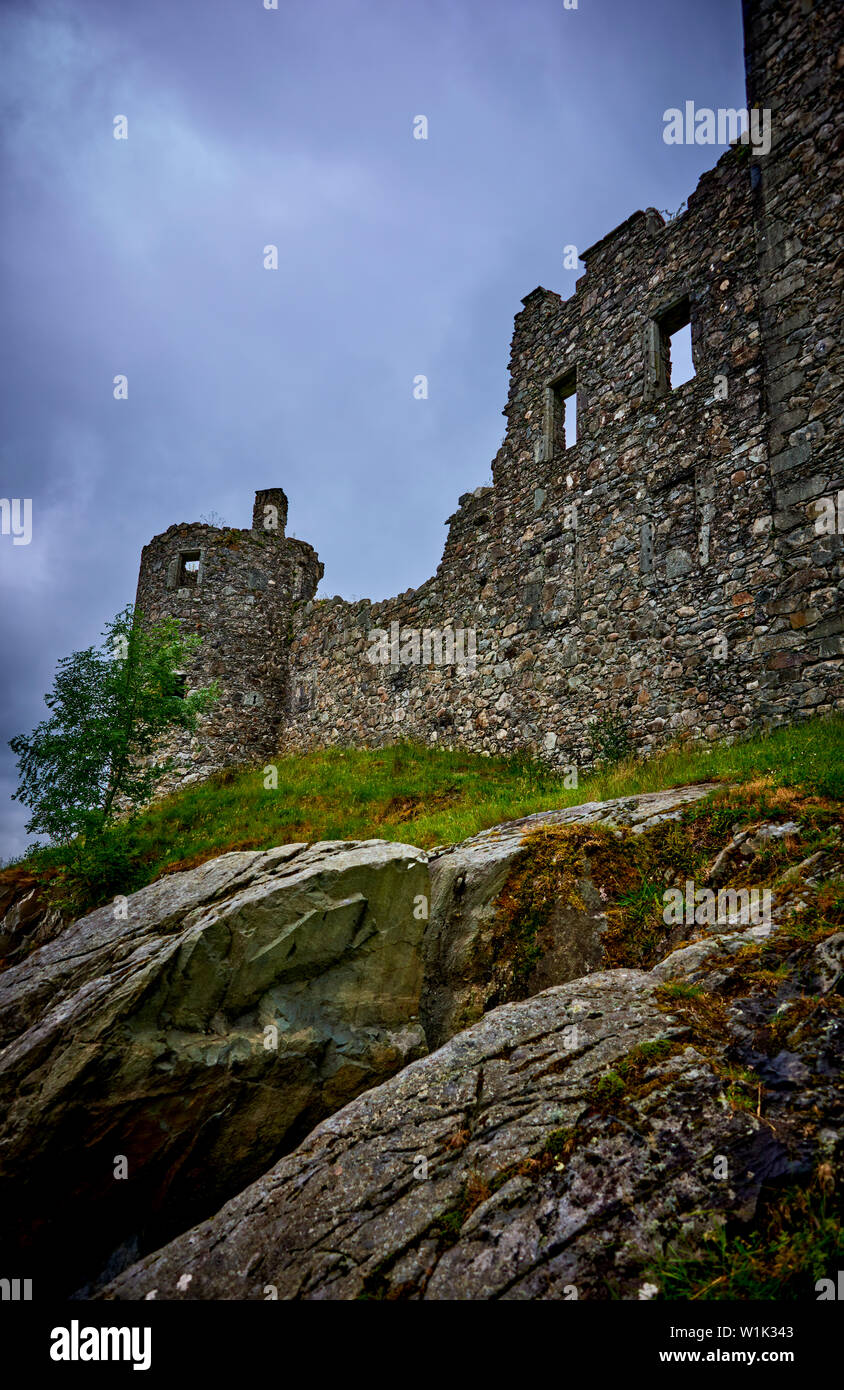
[421,784,713,1048]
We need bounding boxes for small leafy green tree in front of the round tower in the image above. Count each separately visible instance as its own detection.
[10,605,218,845]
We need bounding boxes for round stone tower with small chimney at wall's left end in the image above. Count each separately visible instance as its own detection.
[136,488,323,790]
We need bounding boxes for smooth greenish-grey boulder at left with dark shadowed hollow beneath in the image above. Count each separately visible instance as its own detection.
[0,841,430,1295]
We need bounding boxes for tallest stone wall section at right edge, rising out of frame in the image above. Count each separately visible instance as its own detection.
[744,0,844,713]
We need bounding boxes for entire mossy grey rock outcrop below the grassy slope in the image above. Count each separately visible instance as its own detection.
[0,784,844,1300]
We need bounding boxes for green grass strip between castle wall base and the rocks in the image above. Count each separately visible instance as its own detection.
[138,716,844,877]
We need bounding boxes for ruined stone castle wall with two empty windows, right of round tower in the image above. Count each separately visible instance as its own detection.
[139,0,844,783]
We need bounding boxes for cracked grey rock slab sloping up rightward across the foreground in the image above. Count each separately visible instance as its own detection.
[97,889,844,1300]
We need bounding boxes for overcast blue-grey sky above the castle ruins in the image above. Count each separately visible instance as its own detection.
[0,0,744,856]
